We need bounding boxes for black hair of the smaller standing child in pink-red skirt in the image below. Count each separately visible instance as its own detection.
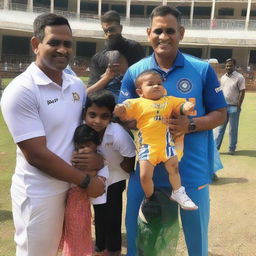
[73,124,100,150]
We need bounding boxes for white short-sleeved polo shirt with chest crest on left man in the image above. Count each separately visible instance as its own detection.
[1,63,85,198]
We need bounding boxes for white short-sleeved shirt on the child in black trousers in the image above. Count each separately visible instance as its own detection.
[98,123,136,186]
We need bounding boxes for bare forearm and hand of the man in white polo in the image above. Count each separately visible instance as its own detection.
[17,136,104,197]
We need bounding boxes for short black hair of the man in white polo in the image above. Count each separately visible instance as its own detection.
[33,13,72,41]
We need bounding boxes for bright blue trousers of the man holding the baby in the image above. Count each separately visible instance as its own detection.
[126,168,210,256]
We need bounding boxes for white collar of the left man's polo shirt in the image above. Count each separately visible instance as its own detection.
[28,62,71,90]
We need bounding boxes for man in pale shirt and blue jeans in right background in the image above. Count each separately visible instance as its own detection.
[214,58,245,155]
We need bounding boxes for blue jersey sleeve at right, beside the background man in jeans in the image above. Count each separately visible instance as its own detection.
[203,64,227,113]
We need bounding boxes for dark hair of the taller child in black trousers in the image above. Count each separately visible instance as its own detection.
[85,90,116,113]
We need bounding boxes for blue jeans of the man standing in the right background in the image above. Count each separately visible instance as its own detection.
[214,105,240,151]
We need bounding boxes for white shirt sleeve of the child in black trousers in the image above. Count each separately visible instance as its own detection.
[113,125,136,157]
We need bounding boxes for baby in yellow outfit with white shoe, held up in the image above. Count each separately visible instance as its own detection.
[114,70,198,210]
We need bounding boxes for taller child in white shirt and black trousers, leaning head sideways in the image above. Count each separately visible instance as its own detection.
[84,90,135,256]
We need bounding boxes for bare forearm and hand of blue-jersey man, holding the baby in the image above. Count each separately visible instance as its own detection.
[168,108,227,136]
